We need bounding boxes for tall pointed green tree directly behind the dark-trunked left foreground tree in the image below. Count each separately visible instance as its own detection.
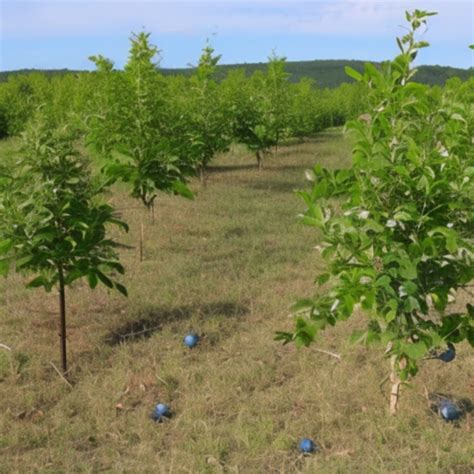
[90,32,192,209]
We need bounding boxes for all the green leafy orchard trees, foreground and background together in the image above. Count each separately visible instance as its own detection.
[0,21,474,412]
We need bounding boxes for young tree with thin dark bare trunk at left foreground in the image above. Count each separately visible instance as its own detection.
[0,114,127,374]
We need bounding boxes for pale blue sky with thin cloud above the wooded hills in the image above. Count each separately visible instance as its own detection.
[0,0,474,70]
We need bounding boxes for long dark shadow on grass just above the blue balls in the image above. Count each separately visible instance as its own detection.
[105,301,249,346]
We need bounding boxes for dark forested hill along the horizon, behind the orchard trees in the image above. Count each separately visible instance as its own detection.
[0,59,474,87]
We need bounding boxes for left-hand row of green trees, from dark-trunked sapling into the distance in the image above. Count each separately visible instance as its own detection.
[5,33,366,373]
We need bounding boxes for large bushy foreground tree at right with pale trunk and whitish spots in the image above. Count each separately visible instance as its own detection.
[277,10,474,414]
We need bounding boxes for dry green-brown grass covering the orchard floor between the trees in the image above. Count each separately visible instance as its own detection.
[0,131,474,474]
